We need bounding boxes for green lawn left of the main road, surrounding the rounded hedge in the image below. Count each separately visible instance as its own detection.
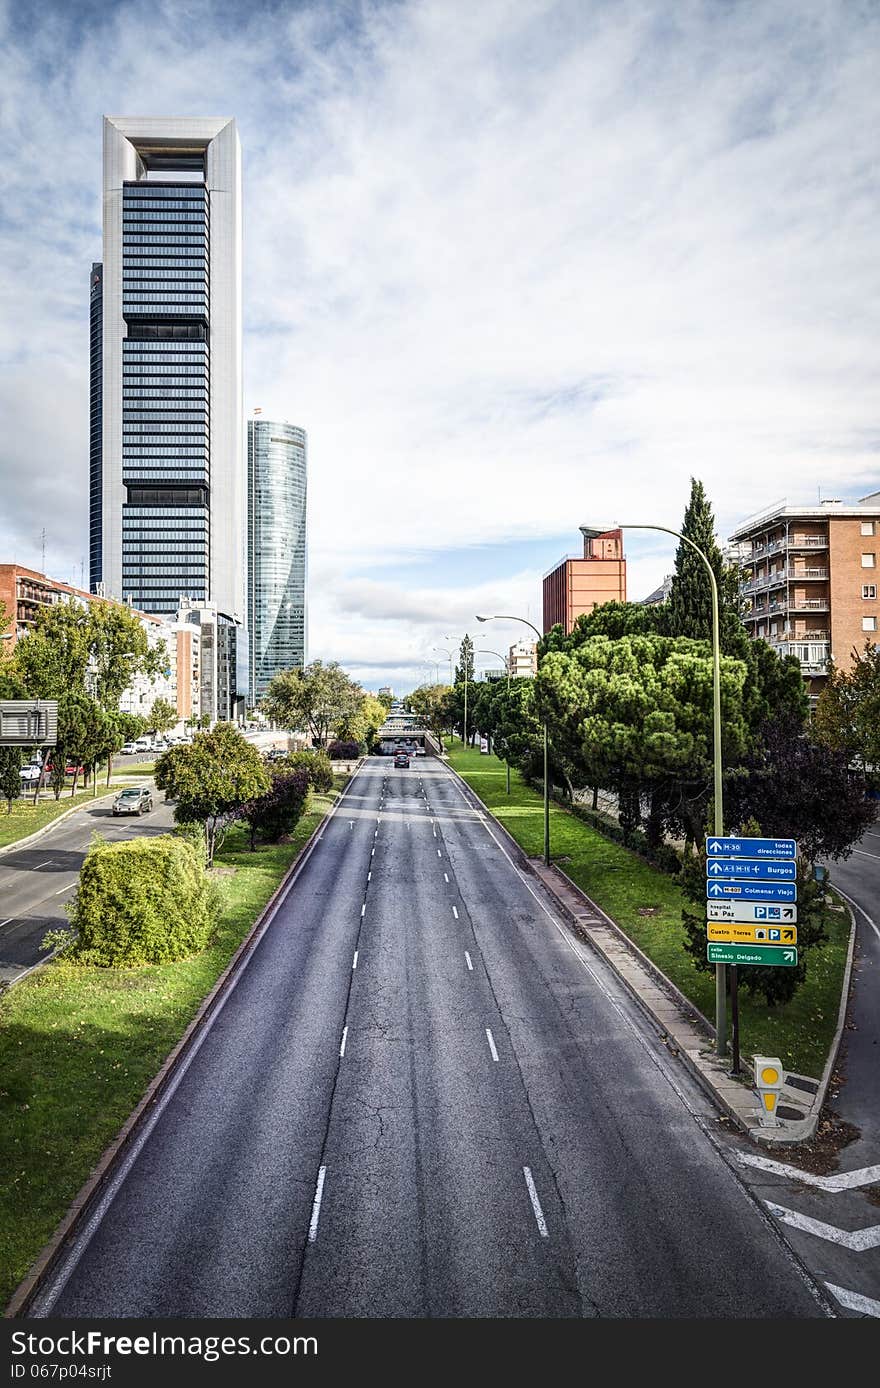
[0,777,346,1305]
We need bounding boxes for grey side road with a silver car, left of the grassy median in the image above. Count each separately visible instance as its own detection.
[0,777,174,983]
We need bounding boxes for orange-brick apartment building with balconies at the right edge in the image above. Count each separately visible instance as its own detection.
[730,491,880,701]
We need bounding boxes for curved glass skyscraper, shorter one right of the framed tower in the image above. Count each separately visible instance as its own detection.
[247,416,307,694]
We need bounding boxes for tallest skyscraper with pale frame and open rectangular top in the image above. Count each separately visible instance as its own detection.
[92,117,244,620]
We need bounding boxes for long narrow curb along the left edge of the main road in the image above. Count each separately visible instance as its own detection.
[3,758,364,1320]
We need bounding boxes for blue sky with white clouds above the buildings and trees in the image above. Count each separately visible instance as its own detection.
[0,0,880,690]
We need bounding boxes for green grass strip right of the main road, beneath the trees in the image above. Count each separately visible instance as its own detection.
[451,738,849,1077]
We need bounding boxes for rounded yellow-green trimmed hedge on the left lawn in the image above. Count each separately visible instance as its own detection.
[67,834,219,969]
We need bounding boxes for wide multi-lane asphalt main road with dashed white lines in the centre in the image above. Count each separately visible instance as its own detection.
[33,758,824,1317]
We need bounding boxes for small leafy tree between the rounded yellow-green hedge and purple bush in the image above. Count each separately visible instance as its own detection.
[155,723,271,866]
